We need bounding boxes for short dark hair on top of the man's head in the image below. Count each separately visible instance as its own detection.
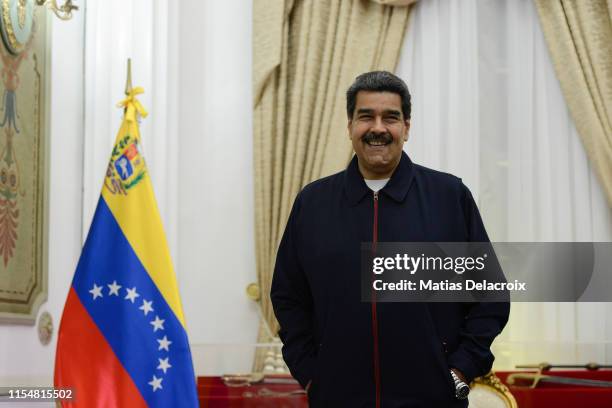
[346,71,412,120]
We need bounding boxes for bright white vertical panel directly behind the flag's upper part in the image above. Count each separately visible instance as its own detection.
[83,0,178,255]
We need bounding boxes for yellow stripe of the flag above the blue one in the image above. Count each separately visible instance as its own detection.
[102,119,185,327]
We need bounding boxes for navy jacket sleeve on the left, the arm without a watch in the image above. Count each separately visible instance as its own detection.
[270,195,316,387]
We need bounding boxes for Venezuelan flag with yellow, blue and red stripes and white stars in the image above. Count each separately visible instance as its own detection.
[55,88,198,408]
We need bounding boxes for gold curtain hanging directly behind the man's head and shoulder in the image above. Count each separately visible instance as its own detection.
[253,0,409,367]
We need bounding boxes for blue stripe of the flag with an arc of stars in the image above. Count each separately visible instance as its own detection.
[72,197,198,407]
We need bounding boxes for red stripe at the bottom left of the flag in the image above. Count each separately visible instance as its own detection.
[55,287,146,407]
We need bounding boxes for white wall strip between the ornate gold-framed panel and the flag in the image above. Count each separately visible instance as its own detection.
[0,10,84,386]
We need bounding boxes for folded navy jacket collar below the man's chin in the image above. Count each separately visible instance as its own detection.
[344,152,414,206]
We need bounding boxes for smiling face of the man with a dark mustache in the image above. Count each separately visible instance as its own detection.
[348,91,410,179]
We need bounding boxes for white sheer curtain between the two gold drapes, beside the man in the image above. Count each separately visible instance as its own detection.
[397,0,612,368]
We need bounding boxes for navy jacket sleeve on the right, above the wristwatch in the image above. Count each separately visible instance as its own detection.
[448,185,510,382]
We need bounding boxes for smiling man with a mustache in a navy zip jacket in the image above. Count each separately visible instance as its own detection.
[271,71,509,408]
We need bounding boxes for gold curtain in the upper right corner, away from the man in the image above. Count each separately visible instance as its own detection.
[535,0,612,206]
